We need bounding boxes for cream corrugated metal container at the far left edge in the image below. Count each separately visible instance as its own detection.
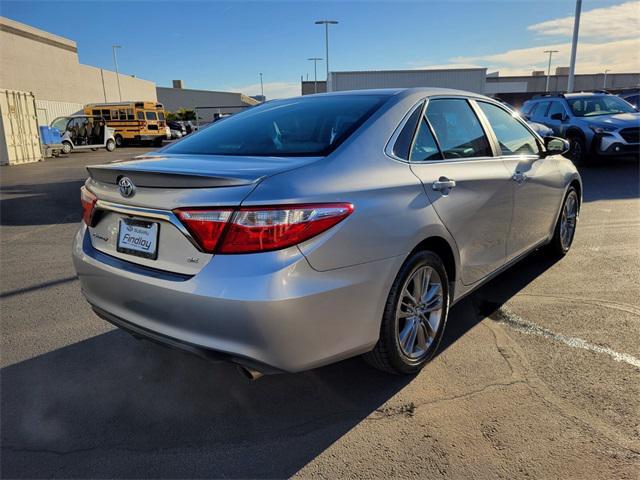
[0,89,42,165]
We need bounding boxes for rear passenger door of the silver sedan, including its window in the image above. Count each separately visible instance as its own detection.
[411,98,513,285]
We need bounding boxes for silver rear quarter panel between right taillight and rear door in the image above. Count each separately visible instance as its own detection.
[243,96,453,271]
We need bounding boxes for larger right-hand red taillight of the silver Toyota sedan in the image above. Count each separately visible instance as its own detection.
[176,203,353,253]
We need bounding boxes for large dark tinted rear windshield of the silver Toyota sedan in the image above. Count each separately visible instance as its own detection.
[163,95,388,157]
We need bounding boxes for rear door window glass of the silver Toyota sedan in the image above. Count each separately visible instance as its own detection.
[427,99,493,158]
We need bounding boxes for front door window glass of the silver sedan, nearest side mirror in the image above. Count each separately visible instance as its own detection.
[478,102,539,155]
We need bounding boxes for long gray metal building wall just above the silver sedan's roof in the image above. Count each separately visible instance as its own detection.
[328,68,487,93]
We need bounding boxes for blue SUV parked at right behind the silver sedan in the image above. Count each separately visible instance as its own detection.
[521,92,640,164]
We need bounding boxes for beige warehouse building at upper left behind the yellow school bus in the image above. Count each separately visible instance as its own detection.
[0,17,157,125]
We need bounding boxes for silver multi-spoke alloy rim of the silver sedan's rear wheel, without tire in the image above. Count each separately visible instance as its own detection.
[396,266,444,361]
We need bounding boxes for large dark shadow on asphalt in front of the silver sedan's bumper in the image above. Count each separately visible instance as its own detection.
[0,331,413,478]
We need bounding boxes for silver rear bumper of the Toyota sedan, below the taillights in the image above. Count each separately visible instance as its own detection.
[73,225,402,373]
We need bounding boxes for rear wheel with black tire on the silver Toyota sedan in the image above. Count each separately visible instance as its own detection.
[363,251,449,375]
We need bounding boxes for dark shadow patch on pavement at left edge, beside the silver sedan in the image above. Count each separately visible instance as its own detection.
[0,180,84,226]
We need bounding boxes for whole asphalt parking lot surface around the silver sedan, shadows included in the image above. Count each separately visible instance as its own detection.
[0,149,640,479]
